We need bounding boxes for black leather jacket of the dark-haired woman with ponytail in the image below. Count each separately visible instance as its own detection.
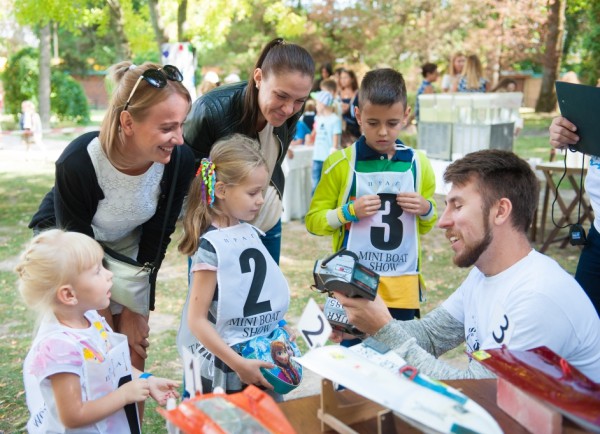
[183,81,302,195]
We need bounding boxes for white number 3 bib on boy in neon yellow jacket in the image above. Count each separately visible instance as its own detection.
[347,170,418,276]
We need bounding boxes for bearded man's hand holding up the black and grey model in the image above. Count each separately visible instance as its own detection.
[335,292,393,335]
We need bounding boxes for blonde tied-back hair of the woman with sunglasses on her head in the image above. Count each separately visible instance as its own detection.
[99,61,192,167]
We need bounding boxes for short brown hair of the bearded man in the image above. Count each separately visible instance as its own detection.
[444,149,540,233]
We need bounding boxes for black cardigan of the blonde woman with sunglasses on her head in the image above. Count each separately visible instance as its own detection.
[29,131,194,310]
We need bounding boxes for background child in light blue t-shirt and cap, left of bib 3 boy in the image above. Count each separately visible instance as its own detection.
[311,90,342,194]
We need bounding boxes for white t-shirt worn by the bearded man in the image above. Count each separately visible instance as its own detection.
[443,250,600,382]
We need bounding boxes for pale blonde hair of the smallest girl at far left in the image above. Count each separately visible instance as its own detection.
[15,229,104,317]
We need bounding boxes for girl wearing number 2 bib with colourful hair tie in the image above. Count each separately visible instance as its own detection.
[177,134,293,399]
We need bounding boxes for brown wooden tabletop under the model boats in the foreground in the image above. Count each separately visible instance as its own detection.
[279,380,581,434]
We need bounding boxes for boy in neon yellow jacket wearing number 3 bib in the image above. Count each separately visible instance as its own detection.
[306,69,437,326]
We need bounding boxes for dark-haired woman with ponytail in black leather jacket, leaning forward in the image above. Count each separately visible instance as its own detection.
[183,38,315,263]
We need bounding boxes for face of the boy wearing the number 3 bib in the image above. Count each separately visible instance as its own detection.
[356,102,410,157]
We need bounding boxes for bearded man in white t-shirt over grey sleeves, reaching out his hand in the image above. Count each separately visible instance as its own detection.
[336,149,600,382]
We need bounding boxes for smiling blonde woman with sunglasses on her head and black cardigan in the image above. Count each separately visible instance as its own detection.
[29,62,194,371]
